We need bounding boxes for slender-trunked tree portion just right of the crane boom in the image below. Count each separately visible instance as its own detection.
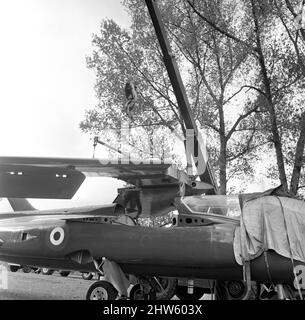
[157,1,258,194]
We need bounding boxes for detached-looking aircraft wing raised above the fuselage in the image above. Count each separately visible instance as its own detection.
[0,157,181,199]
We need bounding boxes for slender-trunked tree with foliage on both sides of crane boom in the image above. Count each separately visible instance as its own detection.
[81,0,266,193]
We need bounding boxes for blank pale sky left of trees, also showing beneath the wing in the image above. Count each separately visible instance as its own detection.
[0,0,130,211]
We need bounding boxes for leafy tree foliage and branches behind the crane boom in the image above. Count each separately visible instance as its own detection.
[81,0,305,194]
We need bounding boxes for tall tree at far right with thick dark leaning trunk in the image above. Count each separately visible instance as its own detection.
[188,0,303,192]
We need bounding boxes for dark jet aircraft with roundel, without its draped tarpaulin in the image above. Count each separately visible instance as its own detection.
[0,157,304,299]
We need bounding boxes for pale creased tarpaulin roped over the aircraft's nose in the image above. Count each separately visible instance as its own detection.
[234,196,305,264]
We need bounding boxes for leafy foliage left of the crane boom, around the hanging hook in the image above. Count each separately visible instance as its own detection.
[80,20,180,162]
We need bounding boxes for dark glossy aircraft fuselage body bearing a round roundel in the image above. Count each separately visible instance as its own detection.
[0,205,300,282]
